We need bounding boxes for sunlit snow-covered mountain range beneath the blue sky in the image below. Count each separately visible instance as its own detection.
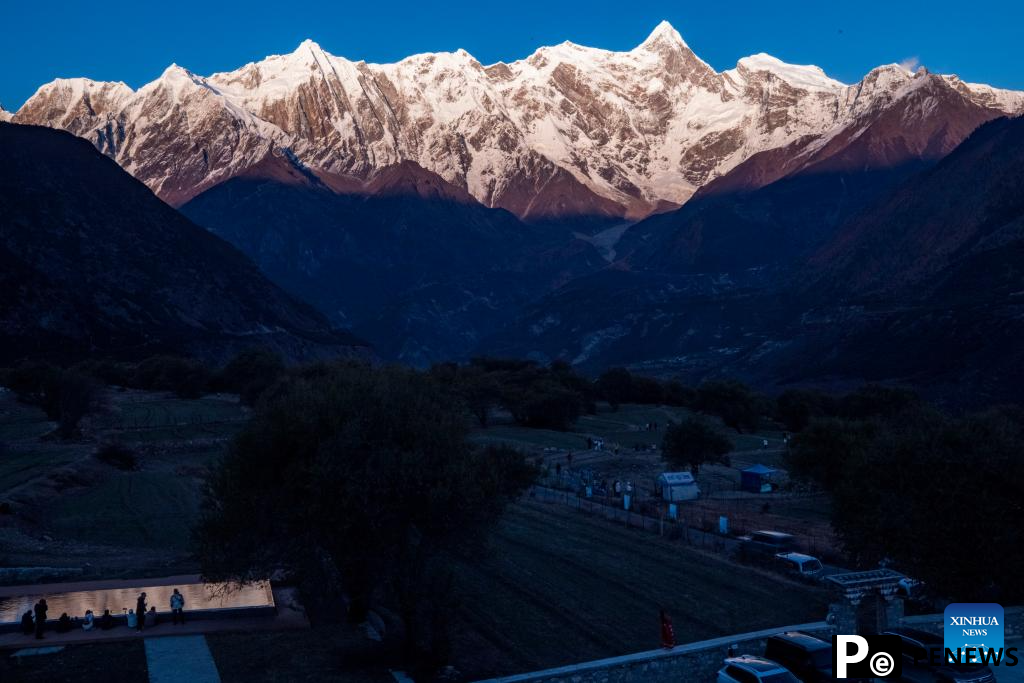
[14,23,1024,220]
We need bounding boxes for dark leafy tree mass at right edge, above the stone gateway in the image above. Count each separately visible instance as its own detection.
[790,405,1024,601]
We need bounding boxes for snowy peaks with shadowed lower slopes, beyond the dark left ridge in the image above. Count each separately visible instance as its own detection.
[8,23,1024,402]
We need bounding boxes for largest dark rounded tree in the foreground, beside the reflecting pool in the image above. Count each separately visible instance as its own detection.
[195,365,535,657]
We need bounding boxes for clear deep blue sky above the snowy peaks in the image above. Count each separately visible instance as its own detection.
[0,0,1024,110]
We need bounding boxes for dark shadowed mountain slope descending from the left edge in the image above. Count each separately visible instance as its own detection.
[0,123,367,361]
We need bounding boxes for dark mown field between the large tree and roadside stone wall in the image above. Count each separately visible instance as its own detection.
[456,502,827,679]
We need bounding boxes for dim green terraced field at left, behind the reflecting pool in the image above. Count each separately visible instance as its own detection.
[0,391,242,573]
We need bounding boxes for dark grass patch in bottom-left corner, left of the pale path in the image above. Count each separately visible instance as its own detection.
[0,640,148,683]
